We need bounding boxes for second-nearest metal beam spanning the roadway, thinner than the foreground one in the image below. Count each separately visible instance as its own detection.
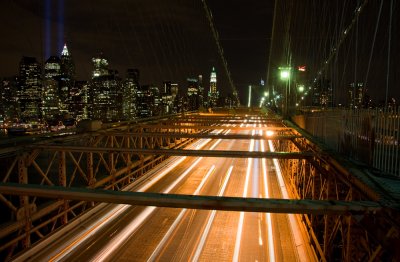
[26,145,315,159]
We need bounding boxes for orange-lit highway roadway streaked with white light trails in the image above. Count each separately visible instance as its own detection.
[20,123,312,261]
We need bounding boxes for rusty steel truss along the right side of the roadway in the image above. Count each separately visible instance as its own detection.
[275,122,400,261]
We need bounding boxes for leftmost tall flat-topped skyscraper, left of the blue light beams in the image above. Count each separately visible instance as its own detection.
[18,56,42,121]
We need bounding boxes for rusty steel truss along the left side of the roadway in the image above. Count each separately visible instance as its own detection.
[0,128,193,257]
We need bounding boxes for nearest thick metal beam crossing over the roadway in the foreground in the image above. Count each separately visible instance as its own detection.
[0,183,383,214]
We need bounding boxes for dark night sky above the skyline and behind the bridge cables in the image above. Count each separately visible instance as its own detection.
[0,0,400,103]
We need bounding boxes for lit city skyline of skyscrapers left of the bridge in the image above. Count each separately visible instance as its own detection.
[0,44,225,128]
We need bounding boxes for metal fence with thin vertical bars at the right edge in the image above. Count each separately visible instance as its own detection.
[292,108,400,177]
